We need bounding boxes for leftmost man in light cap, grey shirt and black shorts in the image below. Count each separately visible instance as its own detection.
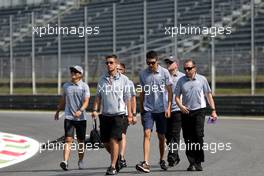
[54,65,90,170]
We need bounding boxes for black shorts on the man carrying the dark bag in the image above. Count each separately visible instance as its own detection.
[99,115,125,143]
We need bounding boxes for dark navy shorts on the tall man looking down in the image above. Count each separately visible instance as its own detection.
[141,111,167,134]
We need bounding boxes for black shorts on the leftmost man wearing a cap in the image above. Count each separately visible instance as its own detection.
[64,119,86,140]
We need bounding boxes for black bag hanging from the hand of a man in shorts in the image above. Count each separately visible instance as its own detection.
[87,119,104,148]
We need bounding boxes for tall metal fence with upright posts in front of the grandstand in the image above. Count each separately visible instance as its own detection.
[0,0,264,95]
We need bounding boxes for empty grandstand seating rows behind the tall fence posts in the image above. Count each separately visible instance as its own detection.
[0,0,264,93]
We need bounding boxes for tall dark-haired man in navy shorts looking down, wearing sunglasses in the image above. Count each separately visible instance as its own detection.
[136,51,172,173]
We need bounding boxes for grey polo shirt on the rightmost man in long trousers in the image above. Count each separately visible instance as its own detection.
[174,74,211,110]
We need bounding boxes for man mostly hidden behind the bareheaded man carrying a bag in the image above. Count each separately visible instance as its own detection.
[117,63,137,169]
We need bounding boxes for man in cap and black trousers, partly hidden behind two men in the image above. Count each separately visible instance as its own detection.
[164,56,184,167]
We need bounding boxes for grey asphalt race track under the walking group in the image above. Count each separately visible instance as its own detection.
[0,111,264,176]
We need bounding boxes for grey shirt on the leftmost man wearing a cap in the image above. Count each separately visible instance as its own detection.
[63,80,90,121]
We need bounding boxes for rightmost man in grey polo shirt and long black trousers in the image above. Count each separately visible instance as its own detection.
[174,59,217,171]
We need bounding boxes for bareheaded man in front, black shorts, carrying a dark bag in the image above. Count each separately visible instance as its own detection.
[92,55,132,175]
